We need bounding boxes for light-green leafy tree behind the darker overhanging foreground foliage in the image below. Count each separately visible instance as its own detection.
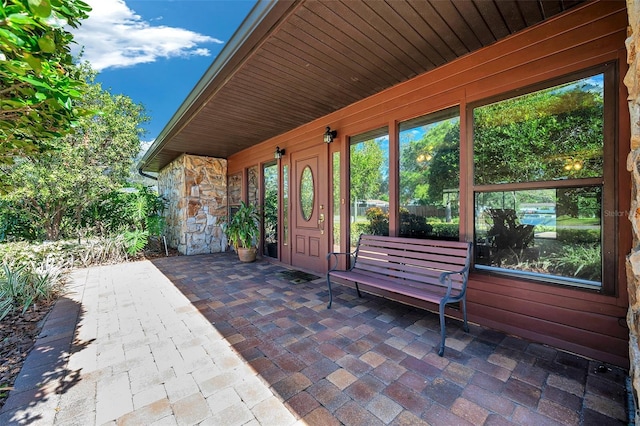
[5,71,147,240]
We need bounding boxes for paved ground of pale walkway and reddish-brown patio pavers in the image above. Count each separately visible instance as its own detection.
[0,254,627,426]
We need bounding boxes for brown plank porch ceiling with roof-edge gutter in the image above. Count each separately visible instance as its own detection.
[139,0,583,171]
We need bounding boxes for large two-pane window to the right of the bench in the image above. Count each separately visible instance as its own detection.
[472,65,615,289]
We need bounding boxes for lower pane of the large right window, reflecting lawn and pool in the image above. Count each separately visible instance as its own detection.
[475,186,602,285]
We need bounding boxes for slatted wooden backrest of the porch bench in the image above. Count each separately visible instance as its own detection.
[352,234,471,291]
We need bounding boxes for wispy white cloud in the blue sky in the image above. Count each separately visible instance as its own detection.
[73,0,223,71]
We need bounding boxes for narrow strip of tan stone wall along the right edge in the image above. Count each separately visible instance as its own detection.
[624,0,640,425]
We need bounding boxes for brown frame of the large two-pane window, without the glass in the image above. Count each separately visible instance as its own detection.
[465,61,619,295]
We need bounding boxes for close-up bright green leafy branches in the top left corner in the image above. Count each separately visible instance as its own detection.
[0,0,91,164]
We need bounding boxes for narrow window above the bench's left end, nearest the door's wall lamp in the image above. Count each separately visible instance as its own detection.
[349,127,389,247]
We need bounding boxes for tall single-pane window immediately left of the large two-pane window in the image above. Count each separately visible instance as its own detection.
[399,107,460,241]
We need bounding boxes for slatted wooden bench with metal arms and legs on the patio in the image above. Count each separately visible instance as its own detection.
[327,235,471,356]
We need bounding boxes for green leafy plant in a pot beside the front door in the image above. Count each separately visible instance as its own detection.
[223,201,260,262]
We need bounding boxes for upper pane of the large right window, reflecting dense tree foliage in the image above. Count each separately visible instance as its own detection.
[473,83,604,184]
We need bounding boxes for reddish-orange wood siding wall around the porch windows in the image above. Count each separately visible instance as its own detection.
[228,1,632,366]
